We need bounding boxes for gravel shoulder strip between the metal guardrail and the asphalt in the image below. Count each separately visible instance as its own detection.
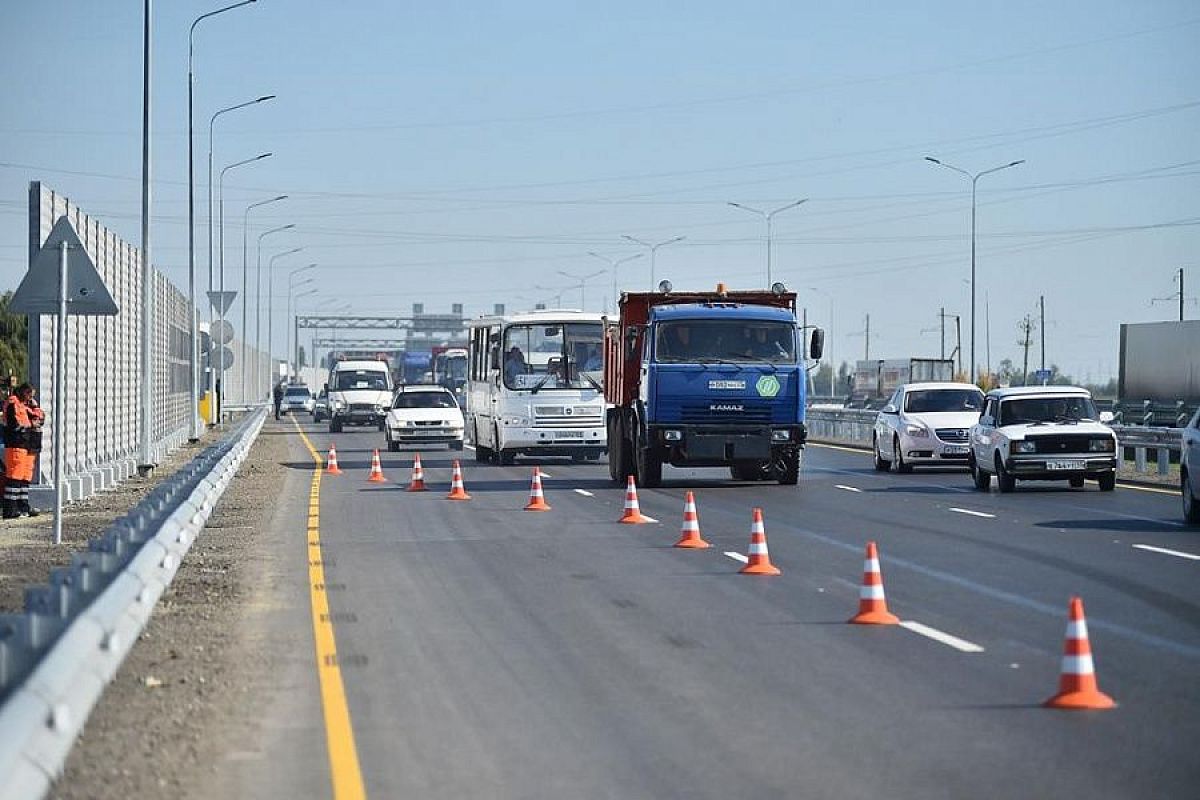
[50,421,301,800]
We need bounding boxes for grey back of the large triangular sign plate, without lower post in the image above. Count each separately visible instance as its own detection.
[8,217,118,315]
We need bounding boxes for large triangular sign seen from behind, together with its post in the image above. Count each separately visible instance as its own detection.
[8,217,118,545]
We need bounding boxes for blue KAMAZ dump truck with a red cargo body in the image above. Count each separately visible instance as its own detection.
[604,282,824,487]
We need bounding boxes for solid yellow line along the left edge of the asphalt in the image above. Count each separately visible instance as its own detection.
[292,417,367,800]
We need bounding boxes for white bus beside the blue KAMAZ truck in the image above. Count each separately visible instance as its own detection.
[466,311,607,464]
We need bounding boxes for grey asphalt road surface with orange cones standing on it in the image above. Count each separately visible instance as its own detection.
[214,417,1200,799]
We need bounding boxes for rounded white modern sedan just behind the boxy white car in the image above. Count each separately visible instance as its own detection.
[871,383,983,473]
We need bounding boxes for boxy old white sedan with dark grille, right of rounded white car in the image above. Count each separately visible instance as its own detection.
[967,386,1117,493]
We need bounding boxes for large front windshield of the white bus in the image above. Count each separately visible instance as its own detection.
[503,323,604,391]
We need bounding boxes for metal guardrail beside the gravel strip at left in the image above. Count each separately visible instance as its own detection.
[0,408,266,800]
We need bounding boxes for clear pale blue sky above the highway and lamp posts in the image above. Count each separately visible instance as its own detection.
[0,0,1200,379]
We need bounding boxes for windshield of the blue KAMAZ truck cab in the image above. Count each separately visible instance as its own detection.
[654,319,796,363]
